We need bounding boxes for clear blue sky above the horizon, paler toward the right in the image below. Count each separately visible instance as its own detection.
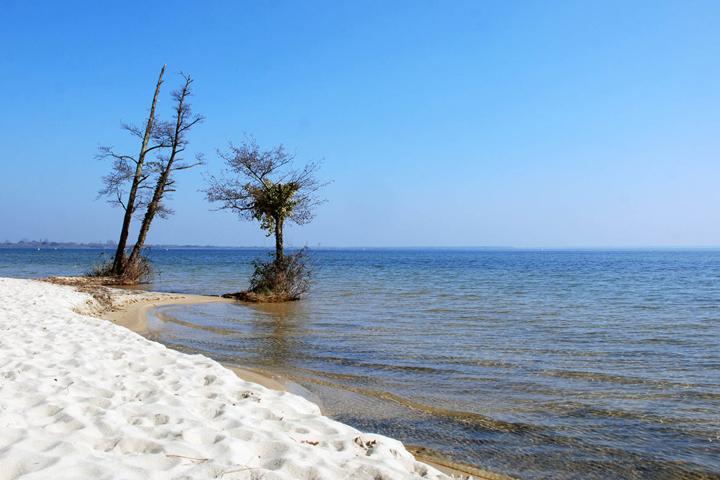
[0,0,720,247]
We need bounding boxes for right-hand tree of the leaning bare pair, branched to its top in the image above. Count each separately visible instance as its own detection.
[127,75,203,265]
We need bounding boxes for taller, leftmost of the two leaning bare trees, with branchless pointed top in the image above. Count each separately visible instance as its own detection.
[98,65,166,275]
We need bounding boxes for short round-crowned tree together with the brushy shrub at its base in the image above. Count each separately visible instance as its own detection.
[205,138,322,301]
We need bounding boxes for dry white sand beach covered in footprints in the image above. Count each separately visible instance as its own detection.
[0,278,449,480]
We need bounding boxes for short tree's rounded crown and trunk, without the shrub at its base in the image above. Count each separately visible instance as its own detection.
[206,138,322,262]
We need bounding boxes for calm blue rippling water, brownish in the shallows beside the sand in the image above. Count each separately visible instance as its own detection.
[0,250,720,479]
